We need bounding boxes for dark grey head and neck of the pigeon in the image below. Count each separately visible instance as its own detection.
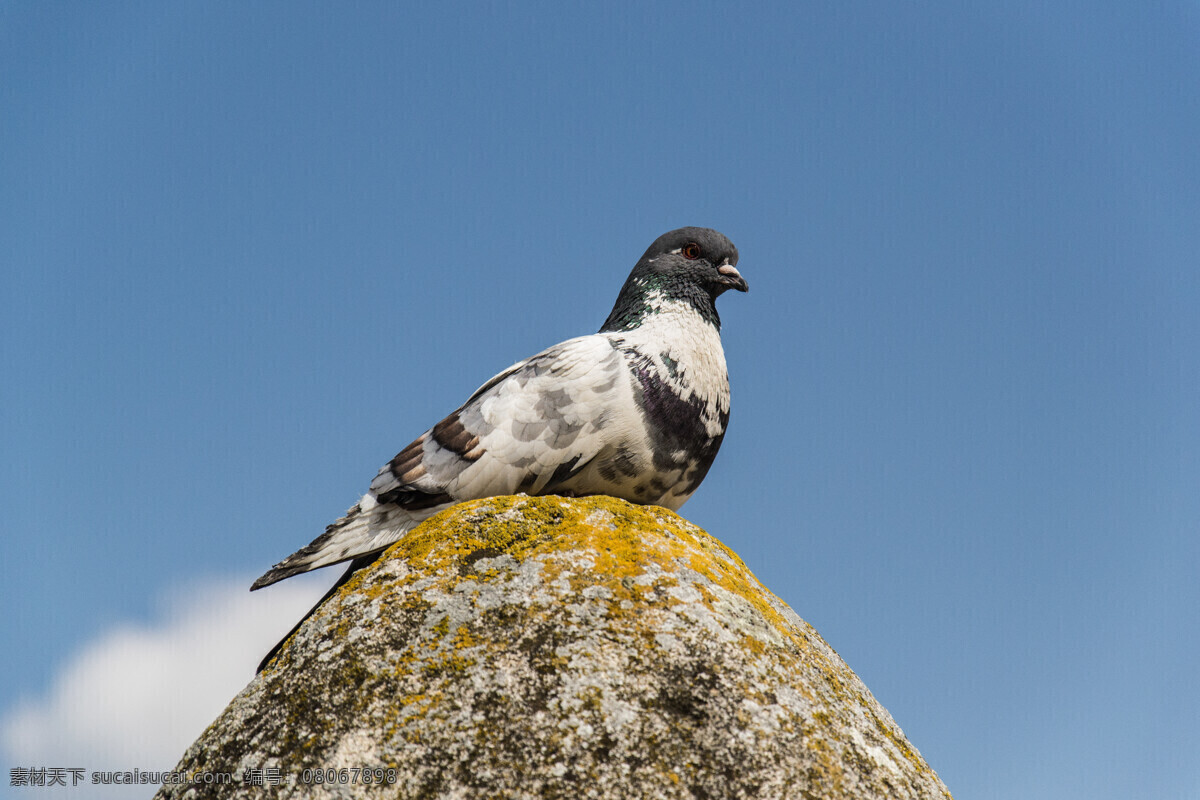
[600,228,749,331]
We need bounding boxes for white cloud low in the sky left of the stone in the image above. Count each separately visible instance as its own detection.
[0,572,336,800]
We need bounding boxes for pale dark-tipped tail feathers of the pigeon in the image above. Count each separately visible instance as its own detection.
[250,494,416,591]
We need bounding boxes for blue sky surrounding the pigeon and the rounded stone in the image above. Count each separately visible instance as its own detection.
[0,2,1200,799]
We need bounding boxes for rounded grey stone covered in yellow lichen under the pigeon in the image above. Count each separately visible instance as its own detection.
[158,497,949,800]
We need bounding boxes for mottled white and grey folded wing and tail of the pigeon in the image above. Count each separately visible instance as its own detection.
[253,335,644,589]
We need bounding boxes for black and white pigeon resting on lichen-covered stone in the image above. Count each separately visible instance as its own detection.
[251,227,749,672]
